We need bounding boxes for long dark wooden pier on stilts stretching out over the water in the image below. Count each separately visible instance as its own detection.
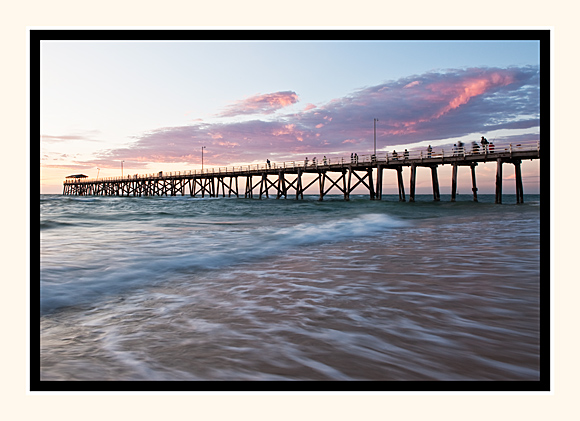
[63,142,540,203]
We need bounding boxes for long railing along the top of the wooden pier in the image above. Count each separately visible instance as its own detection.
[64,141,540,184]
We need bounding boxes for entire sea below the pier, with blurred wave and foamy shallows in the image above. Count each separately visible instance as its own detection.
[38,194,540,381]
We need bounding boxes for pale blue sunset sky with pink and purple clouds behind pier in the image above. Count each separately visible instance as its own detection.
[40,37,540,194]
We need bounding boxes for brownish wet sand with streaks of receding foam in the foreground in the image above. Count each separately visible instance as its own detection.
[41,217,539,380]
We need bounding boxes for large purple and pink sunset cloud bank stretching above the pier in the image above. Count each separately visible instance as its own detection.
[78,66,539,169]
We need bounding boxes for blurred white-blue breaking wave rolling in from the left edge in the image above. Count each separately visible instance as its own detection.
[41,214,405,314]
